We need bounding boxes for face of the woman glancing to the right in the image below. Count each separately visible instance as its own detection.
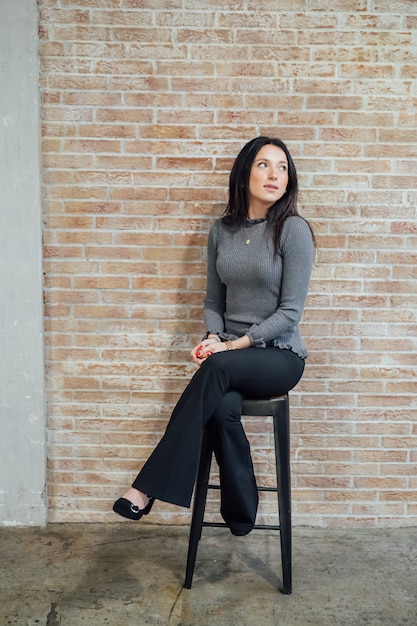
[249,144,288,217]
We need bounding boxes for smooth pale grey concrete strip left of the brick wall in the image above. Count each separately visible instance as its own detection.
[0,0,47,525]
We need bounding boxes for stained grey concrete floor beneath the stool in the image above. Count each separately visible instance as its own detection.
[0,521,417,626]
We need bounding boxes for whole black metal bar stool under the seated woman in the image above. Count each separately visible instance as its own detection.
[184,395,292,594]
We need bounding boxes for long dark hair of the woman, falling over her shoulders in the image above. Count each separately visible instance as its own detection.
[222,136,315,252]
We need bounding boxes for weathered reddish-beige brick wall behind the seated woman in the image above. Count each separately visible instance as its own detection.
[39,0,417,527]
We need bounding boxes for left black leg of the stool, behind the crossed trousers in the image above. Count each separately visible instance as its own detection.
[184,432,213,589]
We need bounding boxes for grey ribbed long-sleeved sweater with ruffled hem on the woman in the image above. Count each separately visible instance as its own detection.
[204,216,313,358]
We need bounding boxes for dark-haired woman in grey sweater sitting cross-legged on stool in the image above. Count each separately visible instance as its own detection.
[113,137,314,535]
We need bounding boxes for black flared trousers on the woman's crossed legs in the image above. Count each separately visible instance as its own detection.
[132,347,304,524]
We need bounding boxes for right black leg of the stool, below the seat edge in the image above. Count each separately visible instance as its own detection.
[273,398,292,594]
